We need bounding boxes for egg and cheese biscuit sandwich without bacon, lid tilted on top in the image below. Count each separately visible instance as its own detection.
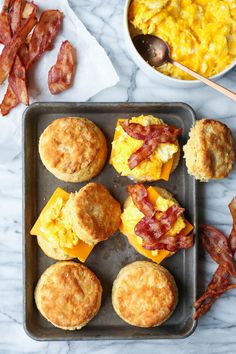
[30,183,121,262]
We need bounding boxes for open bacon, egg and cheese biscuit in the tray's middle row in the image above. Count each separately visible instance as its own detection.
[120,183,193,263]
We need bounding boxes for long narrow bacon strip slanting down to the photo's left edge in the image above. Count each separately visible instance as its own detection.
[0,13,37,84]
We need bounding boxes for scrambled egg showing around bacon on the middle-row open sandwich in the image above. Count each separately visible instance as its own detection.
[121,196,186,243]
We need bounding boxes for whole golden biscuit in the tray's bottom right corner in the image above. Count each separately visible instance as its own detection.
[112,261,178,327]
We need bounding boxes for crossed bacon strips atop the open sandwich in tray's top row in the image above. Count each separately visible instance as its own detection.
[121,119,182,170]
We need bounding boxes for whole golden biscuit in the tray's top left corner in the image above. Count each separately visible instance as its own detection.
[39,117,107,182]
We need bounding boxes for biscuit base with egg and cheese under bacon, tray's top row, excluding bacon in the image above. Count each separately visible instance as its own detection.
[110,115,180,182]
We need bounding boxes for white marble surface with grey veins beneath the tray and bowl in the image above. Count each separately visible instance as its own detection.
[0,0,236,354]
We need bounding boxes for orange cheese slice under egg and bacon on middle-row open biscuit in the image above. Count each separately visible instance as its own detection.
[120,187,193,264]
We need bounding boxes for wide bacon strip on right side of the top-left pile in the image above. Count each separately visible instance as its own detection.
[26,10,63,69]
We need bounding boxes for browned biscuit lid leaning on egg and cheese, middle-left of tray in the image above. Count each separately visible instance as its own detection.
[64,183,121,245]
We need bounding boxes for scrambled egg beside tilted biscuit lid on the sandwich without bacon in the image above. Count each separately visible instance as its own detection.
[40,198,79,248]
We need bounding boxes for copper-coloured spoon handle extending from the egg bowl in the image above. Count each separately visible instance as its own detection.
[171,60,236,101]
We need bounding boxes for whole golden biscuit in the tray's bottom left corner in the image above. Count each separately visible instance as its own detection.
[35,261,102,330]
